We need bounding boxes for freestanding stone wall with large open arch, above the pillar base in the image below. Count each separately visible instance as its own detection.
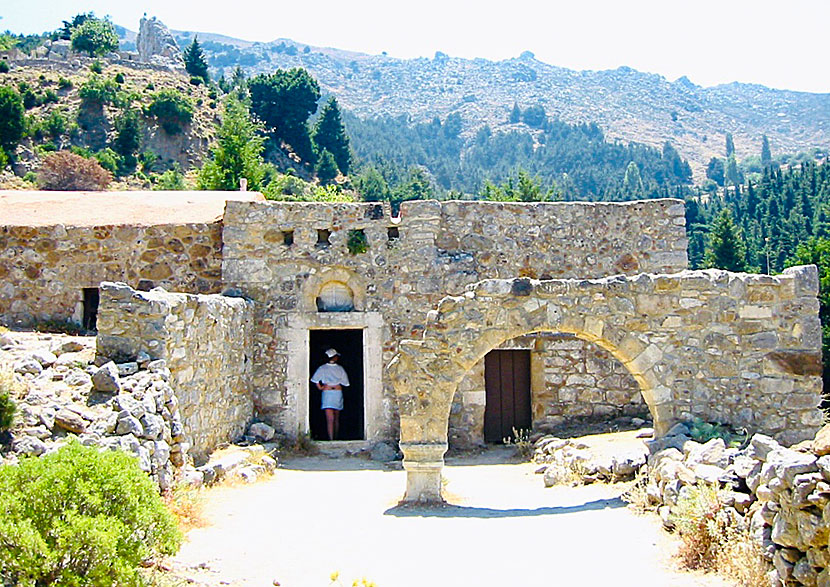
[387,265,822,445]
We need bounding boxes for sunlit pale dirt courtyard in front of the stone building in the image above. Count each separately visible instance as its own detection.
[176,453,726,587]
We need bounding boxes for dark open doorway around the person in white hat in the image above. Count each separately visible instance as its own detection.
[308,329,365,440]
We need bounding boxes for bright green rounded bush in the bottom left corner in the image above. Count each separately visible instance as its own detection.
[0,441,181,587]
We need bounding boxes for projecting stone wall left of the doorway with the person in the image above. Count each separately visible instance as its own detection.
[97,283,253,463]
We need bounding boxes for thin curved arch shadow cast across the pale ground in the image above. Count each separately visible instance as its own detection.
[383,497,626,518]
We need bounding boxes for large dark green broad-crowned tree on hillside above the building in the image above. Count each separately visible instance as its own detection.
[248,67,320,164]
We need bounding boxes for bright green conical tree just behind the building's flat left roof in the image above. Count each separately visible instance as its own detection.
[199,97,265,190]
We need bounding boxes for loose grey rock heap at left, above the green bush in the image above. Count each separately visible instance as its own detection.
[2,341,192,490]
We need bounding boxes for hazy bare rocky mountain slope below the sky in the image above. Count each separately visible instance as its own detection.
[161,31,830,176]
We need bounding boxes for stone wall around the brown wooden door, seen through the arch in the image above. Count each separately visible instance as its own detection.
[449,332,648,448]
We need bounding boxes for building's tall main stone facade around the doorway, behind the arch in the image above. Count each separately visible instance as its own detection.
[222,200,687,437]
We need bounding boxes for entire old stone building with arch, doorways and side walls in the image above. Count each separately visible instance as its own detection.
[0,192,821,500]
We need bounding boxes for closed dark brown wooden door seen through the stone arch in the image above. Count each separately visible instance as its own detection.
[484,351,531,442]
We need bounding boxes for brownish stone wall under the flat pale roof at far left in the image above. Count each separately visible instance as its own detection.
[0,220,222,325]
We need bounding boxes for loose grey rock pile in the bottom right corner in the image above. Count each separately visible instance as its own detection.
[646,426,830,585]
